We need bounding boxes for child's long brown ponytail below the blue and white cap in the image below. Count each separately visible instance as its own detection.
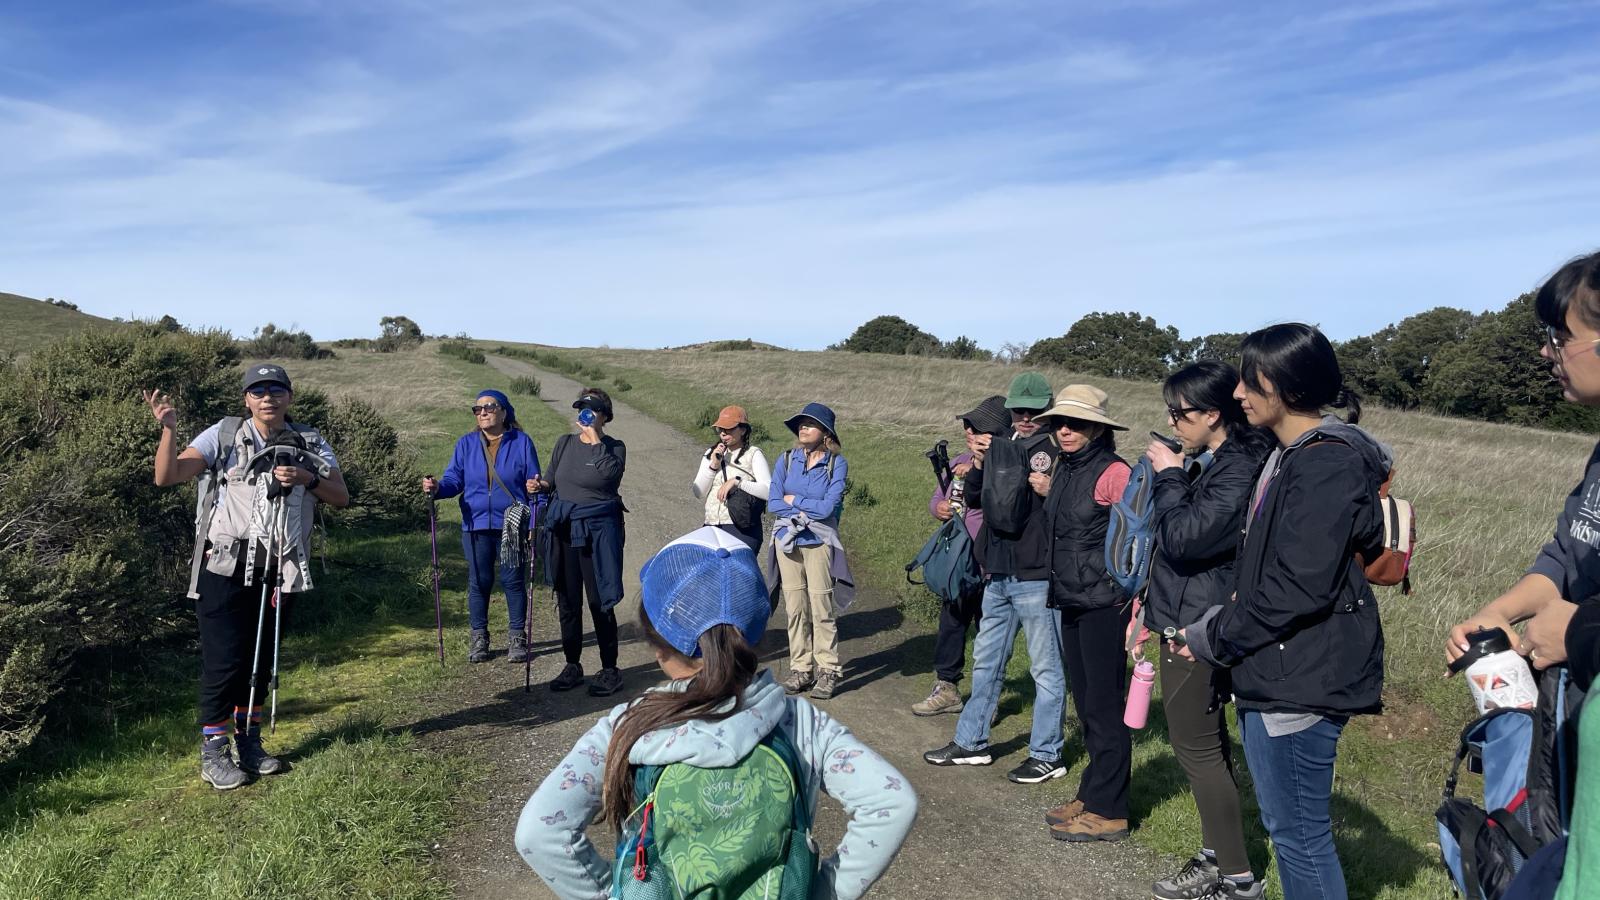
[600,604,760,833]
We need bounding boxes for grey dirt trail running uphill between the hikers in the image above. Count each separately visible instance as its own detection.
[413,357,1165,900]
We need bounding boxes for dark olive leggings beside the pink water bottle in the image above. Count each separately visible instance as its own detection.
[1162,650,1250,874]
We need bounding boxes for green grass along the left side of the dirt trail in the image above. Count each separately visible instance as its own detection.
[0,342,566,898]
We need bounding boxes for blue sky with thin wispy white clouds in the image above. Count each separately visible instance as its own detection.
[0,0,1600,348]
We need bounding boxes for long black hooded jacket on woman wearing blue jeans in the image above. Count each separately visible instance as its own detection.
[1189,420,1390,716]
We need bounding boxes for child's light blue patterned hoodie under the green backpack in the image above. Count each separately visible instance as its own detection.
[517,669,917,900]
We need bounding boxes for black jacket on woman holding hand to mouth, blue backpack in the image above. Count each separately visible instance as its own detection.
[1144,440,1266,631]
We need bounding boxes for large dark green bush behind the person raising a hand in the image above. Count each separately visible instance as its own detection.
[0,323,424,762]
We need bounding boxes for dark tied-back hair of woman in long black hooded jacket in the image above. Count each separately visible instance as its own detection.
[1238,322,1362,424]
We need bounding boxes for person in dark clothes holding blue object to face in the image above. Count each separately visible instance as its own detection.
[528,388,627,697]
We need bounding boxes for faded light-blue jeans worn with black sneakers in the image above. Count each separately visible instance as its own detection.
[955,578,1067,762]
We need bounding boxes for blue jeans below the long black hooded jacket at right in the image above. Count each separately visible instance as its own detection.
[1238,709,1347,900]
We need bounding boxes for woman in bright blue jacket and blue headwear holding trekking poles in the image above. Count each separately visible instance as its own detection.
[422,391,539,663]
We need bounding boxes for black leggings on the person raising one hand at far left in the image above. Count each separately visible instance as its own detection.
[195,560,294,727]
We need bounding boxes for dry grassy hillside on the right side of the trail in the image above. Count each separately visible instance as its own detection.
[508,341,1592,897]
